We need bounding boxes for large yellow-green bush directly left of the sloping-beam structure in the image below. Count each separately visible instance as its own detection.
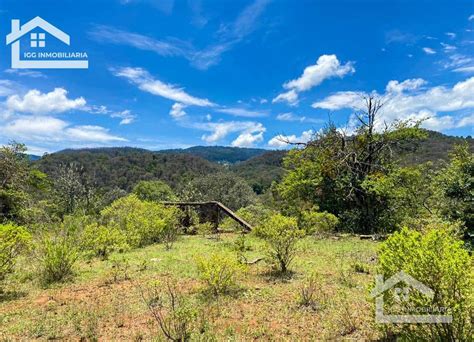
[101,195,179,248]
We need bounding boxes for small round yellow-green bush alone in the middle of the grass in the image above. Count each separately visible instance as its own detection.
[197,253,243,297]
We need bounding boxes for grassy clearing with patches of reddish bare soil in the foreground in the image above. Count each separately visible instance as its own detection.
[0,234,377,341]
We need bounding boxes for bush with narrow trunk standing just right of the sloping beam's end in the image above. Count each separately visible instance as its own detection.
[255,214,304,273]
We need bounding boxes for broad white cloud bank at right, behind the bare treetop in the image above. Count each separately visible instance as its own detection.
[313,77,474,130]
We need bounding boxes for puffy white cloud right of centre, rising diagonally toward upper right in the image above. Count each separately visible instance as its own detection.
[273,55,355,104]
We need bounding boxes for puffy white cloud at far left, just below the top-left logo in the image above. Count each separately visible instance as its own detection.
[6,88,86,114]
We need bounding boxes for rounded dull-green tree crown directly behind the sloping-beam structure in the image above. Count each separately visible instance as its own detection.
[181,172,256,210]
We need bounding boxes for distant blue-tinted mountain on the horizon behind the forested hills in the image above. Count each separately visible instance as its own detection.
[158,146,268,164]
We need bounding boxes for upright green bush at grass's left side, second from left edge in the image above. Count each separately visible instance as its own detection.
[35,229,79,285]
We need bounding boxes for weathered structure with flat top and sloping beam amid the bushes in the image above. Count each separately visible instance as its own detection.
[162,201,252,232]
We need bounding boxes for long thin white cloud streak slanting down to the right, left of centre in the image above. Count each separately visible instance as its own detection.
[112,67,214,107]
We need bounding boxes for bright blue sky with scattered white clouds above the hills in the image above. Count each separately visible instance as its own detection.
[0,0,474,154]
